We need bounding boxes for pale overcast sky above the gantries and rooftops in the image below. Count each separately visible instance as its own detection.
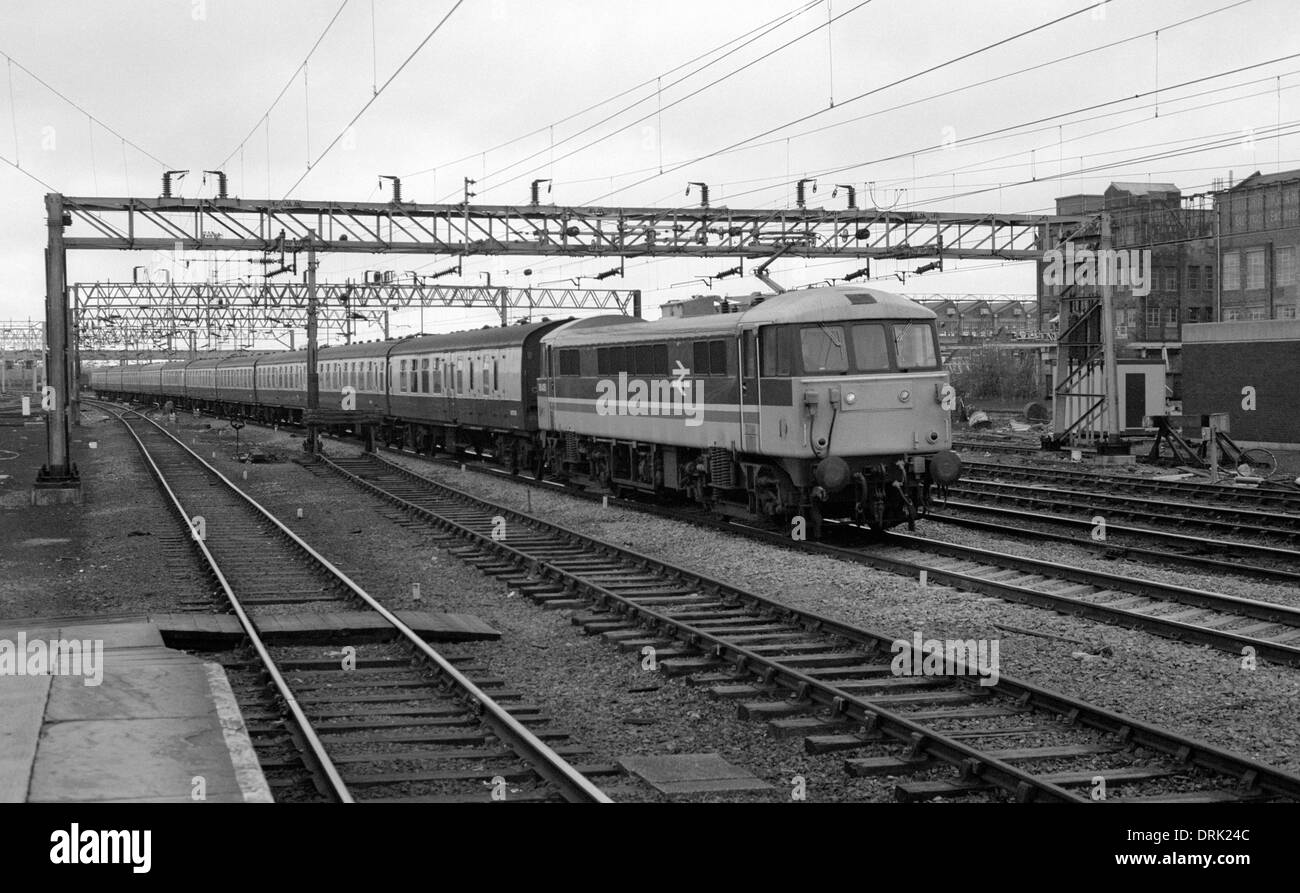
[0,0,1300,340]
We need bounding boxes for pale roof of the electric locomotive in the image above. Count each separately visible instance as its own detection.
[545,286,935,347]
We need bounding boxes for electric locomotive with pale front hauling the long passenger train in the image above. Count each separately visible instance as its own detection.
[538,287,961,537]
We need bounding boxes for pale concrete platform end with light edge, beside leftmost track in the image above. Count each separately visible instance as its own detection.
[0,620,272,802]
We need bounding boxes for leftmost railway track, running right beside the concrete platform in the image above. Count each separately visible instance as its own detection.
[94,407,618,802]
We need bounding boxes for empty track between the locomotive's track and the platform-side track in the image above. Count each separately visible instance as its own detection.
[322,455,1300,802]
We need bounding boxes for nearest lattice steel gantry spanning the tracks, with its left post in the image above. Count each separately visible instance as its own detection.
[38,192,1075,499]
